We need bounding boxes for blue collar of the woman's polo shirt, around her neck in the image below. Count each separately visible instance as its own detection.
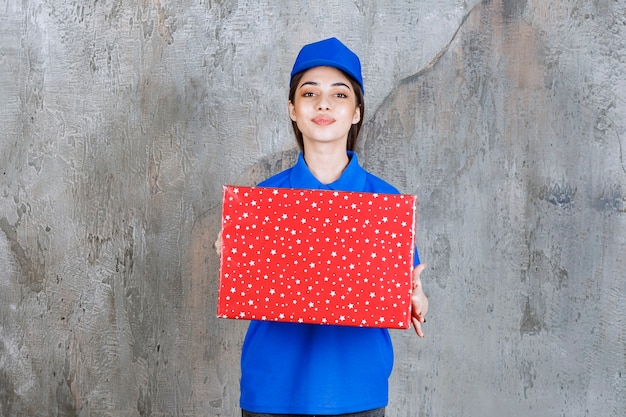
[289,151,367,191]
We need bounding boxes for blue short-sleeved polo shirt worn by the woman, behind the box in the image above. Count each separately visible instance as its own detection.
[240,151,419,414]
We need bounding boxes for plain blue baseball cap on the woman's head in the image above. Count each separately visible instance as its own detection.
[290,38,365,92]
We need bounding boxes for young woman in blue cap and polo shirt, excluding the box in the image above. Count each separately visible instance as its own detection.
[216,38,428,417]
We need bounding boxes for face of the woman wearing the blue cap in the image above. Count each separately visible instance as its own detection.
[289,67,361,150]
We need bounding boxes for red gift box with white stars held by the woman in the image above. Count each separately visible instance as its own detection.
[217,186,417,328]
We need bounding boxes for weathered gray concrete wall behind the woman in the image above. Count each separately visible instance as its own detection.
[0,0,626,417]
